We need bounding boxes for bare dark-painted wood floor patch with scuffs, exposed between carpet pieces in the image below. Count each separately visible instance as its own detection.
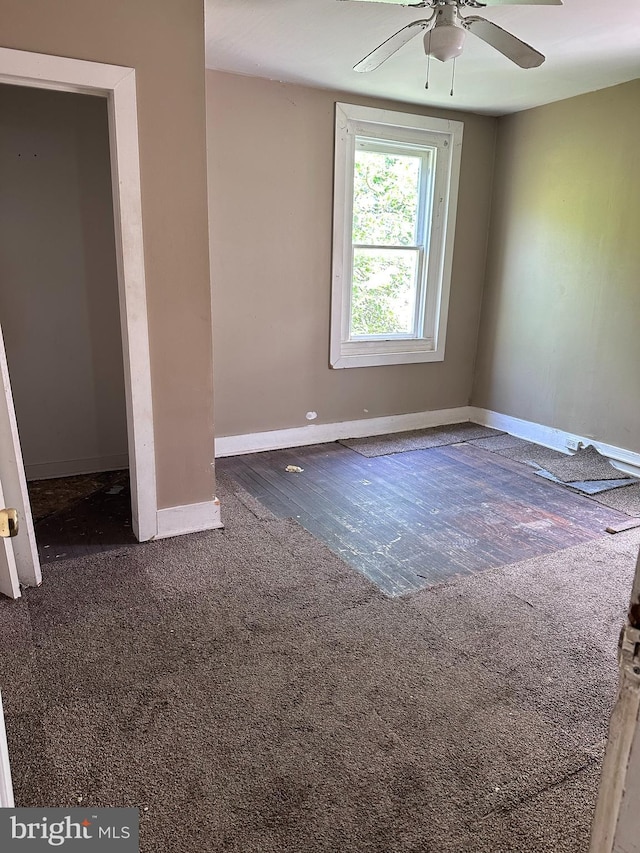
[216,444,626,596]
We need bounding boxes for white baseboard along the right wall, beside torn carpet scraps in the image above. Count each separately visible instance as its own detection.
[470,406,640,477]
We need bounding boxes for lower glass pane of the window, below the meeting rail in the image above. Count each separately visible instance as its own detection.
[351,249,418,339]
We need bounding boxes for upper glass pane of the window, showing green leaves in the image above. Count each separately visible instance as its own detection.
[353,150,422,246]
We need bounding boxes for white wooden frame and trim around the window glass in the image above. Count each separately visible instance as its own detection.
[330,103,464,368]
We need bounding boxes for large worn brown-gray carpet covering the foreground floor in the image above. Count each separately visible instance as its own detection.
[0,472,640,853]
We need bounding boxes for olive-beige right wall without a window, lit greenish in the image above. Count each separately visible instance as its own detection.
[473,80,640,451]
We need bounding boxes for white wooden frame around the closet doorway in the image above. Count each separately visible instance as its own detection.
[0,48,158,542]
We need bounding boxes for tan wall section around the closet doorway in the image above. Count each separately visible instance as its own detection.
[0,0,214,507]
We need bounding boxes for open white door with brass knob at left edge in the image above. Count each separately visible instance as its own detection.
[0,322,42,598]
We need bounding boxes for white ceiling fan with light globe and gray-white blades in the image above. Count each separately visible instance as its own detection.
[342,0,562,71]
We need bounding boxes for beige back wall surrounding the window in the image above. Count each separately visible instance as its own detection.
[207,71,496,435]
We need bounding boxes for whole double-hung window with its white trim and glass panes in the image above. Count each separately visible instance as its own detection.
[331,104,462,367]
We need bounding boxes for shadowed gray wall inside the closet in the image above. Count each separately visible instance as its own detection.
[0,86,127,478]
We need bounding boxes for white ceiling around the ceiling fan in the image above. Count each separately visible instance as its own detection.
[206,0,640,115]
